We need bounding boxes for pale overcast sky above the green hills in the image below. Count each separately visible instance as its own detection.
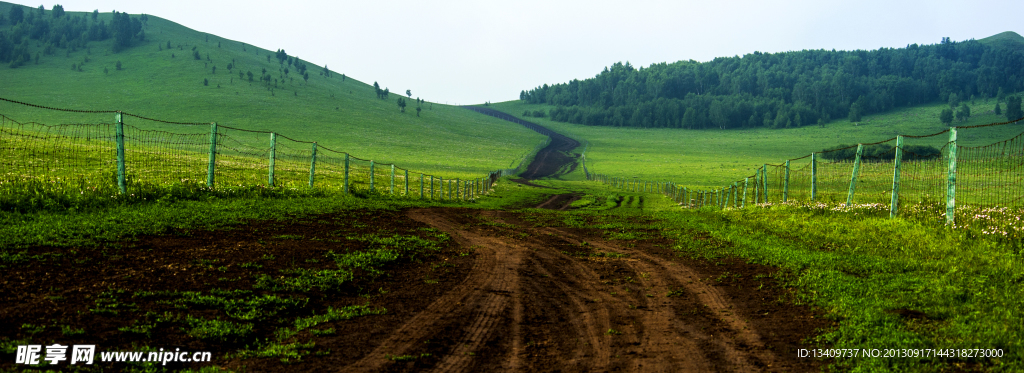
[6,0,1024,105]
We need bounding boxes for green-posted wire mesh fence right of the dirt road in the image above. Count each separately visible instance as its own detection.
[588,118,1024,223]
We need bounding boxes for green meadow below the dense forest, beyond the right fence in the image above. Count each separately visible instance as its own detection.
[493,100,1024,189]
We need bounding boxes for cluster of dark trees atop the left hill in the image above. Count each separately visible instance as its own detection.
[0,4,148,68]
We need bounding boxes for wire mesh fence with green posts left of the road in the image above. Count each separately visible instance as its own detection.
[0,97,522,200]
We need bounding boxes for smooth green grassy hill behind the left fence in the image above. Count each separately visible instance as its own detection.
[0,3,543,177]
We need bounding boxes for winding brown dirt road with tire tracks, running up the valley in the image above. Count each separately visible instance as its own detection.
[344,108,822,372]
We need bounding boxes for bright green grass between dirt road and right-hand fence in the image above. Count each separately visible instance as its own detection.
[524,172,1024,372]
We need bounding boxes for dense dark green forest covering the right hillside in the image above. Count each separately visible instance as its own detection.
[519,34,1024,129]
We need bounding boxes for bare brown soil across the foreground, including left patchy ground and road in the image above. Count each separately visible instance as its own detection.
[0,107,830,372]
